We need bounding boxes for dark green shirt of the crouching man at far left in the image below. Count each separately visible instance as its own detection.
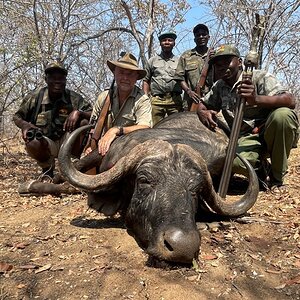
[15,87,92,140]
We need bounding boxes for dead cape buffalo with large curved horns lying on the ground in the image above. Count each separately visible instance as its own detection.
[59,112,259,263]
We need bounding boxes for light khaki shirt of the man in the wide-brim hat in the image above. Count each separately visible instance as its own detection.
[91,86,152,128]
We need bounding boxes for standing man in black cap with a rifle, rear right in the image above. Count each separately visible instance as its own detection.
[174,24,212,110]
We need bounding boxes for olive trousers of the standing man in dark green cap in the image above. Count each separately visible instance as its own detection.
[151,94,183,126]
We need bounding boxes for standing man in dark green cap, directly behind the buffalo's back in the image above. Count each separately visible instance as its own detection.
[143,32,183,125]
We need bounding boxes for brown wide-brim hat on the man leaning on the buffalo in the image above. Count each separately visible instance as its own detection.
[107,52,147,79]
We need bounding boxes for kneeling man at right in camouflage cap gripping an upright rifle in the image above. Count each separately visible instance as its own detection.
[198,45,299,188]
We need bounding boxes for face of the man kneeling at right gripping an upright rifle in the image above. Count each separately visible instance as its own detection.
[214,55,242,85]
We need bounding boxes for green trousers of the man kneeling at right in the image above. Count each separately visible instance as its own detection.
[233,107,299,184]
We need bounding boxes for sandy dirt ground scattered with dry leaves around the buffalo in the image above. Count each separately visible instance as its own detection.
[0,138,300,300]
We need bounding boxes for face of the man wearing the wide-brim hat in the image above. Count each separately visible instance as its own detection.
[114,67,138,93]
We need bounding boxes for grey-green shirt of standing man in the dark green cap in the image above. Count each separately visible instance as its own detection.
[143,53,182,96]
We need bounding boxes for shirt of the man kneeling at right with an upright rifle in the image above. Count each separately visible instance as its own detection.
[204,70,287,134]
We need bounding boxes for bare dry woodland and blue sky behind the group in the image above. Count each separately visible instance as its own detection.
[0,0,300,133]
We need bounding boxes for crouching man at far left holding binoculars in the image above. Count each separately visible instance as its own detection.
[13,61,92,177]
